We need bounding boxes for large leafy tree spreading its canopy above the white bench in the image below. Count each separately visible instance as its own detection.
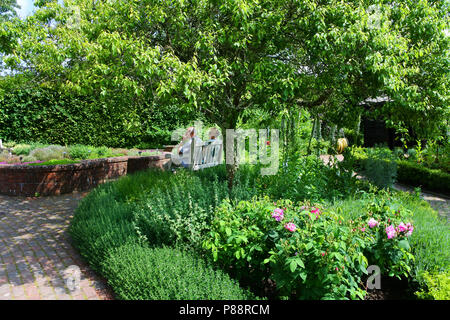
[4,0,449,185]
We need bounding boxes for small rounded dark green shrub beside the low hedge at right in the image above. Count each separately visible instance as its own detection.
[363,148,397,188]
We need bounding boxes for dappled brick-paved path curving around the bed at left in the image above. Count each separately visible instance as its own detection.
[0,193,112,300]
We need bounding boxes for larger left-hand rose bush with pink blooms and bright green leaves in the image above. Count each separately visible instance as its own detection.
[203,197,368,299]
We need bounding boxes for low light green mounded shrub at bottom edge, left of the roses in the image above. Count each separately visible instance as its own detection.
[103,244,254,300]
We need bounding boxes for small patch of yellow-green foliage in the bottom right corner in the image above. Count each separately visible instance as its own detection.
[416,271,450,301]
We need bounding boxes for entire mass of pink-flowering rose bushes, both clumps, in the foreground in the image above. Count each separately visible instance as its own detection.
[203,197,414,299]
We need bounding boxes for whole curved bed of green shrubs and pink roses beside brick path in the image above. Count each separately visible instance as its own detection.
[69,166,449,300]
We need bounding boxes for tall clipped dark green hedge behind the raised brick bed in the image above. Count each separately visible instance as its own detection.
[0,86,198,148]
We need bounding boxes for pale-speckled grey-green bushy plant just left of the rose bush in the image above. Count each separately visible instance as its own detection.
[128,167,256,248]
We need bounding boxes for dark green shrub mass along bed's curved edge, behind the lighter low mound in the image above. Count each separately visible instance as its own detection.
[69,166,256,268]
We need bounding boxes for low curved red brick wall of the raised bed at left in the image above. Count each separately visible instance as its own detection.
[0,154,171,196]
